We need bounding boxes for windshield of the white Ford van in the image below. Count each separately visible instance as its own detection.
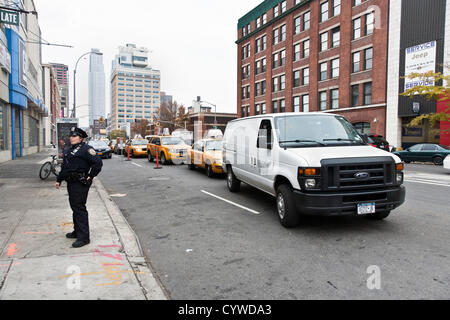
[275,115,365,148]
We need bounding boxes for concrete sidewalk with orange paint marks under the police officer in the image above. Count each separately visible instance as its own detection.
[0,151,166,300]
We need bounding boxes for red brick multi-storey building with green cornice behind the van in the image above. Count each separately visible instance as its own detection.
[236,0,389,135]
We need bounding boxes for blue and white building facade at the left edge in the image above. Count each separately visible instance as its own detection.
[0,0,48,162]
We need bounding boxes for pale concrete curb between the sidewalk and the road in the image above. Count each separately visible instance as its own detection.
[93,178,169,300]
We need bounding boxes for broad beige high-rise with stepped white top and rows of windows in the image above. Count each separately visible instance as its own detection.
[110,44,161,130]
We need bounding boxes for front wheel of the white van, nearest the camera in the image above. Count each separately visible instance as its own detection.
[277,184,300,228]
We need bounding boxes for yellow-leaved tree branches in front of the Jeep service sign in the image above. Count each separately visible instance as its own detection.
[400,66,450,132]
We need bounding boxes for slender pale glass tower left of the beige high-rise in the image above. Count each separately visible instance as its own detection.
[89,49,106,126]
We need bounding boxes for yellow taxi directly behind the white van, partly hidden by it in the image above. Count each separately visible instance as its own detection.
[187,139,224,178]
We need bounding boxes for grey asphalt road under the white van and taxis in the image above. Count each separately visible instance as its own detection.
[99,156,450,300]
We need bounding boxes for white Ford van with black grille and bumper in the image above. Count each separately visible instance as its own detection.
[223,113,405,228]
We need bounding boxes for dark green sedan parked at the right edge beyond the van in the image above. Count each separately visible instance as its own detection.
[394,143,450,166]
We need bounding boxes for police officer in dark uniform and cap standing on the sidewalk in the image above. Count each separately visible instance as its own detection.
[56,128,103,248]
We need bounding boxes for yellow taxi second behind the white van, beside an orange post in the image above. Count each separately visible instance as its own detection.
[147,136,191,165]
